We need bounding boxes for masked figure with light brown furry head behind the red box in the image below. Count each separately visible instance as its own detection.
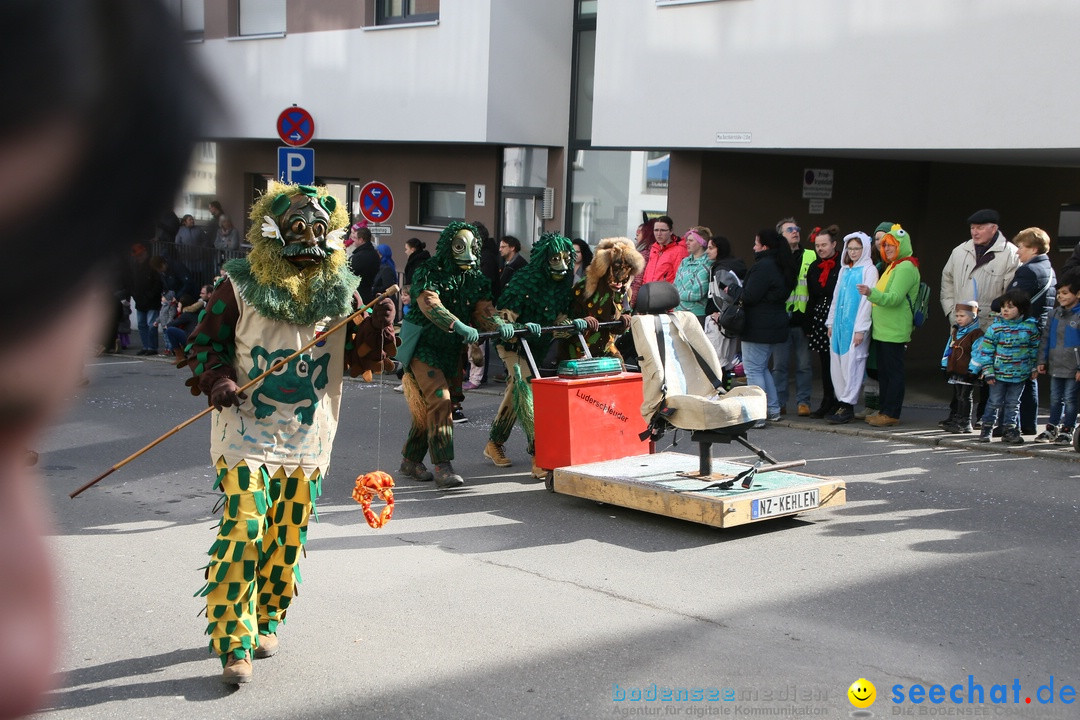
[561,237,645,359]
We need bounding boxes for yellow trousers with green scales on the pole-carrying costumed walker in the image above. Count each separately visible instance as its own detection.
[197,462,322,665]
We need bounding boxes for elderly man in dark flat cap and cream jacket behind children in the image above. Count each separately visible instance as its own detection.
[941,209,1020,329]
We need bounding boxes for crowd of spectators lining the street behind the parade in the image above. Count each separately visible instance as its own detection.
[118,201,1080,444]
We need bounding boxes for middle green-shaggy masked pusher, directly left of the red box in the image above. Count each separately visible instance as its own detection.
[484,232,588,476]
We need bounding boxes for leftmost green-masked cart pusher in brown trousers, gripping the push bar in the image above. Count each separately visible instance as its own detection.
[397,222,514,490]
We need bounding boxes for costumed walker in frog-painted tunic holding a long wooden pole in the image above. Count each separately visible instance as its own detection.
[185,182,392,684]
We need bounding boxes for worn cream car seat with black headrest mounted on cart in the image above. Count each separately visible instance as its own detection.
[630,283,774,476]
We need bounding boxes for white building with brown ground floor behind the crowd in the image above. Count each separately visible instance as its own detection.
[181,0,1080,362]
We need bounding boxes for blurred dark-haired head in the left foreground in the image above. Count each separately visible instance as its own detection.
[0,0,213,718]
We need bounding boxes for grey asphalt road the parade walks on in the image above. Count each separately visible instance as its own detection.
[31,357,1080,720]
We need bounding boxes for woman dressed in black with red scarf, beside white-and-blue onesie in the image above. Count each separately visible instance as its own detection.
[802,225,843,420]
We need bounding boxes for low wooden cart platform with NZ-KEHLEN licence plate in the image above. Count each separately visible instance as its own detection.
[548,452,847,528]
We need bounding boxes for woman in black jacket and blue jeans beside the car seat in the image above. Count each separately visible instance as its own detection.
[742,229,794,427]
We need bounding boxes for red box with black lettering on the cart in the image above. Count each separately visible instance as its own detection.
[532,372,651,470]
